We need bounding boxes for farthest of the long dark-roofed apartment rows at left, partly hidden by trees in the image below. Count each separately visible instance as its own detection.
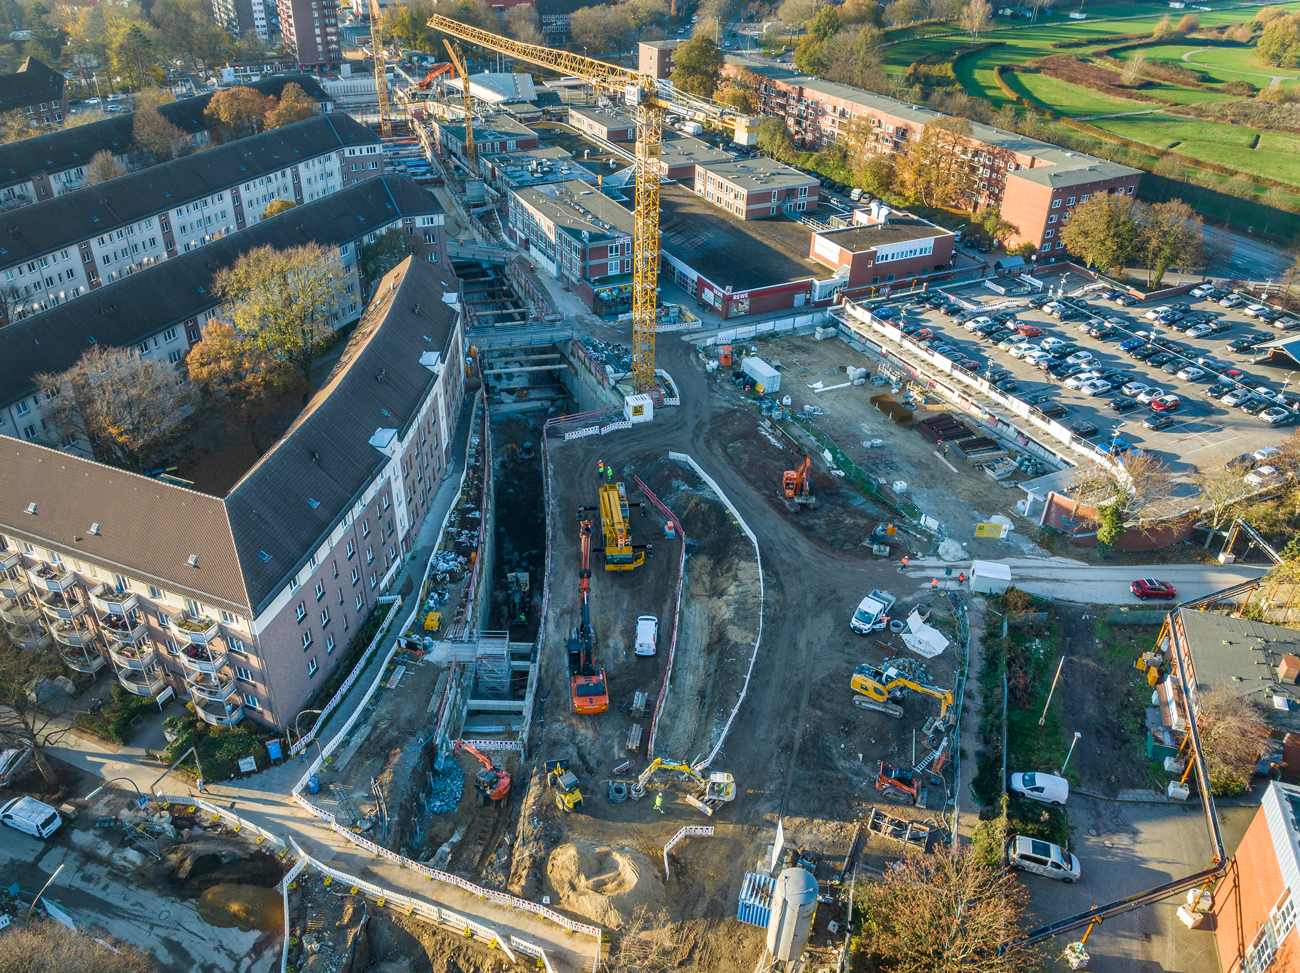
[0,74,333,209]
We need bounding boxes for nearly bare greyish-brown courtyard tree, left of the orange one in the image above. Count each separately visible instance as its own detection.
[35,345,196,472]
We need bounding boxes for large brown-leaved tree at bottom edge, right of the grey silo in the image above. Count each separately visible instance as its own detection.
[859,846,1040,973]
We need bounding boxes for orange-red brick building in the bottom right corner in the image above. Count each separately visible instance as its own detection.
[1213,780,1300,973]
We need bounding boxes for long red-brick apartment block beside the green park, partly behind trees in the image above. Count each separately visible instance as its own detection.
[725,56,1141,256]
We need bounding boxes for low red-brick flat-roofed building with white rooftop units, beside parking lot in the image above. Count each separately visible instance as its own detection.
[809,203,956,290]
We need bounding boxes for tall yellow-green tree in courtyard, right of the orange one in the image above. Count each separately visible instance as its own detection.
[213,243,347,405]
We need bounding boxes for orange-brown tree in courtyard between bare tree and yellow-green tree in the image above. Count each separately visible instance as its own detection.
[185,321,297,457]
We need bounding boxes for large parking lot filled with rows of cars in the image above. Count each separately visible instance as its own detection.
[885,277,1300,475]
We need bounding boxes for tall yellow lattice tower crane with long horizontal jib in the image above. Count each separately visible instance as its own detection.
[423,12,758,392]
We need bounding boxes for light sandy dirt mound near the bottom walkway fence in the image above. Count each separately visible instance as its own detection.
[546,842,664,929]
